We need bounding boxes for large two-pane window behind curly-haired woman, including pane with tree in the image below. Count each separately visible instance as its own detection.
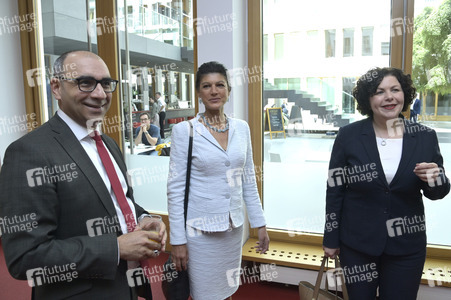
[262,0,451,245]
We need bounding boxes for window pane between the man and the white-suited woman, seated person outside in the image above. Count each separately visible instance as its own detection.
[118,0,195,212]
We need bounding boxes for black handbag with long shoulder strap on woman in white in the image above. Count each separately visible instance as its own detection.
[161,122,193,300]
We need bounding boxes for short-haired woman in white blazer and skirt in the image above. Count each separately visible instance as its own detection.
[168,62,269,300]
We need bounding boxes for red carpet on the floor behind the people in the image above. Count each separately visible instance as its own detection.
[0,241,299,300]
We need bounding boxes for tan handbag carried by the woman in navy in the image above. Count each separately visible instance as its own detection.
[299,256,349,300]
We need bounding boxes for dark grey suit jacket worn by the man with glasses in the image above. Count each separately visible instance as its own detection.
[0,115,151,300]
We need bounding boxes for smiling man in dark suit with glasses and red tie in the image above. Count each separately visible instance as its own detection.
[0,51,166,300]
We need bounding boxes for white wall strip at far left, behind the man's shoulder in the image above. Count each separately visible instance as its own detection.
[0,1,27,162]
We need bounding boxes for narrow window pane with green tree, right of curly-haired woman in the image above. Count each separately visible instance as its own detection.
[414,0,451,245]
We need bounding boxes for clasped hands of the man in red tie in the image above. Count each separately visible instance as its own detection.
[117,228,161,261]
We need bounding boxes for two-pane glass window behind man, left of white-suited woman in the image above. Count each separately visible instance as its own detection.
[42,0,195,212]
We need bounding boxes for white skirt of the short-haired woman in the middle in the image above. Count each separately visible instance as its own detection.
[186,225,243,300]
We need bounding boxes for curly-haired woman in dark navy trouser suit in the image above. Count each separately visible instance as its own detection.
[323,68,450,300]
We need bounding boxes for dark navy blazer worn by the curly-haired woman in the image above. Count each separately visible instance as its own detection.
[323,118,450,256]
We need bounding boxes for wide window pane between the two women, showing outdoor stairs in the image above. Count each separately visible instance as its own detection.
[263,0,391,233]
